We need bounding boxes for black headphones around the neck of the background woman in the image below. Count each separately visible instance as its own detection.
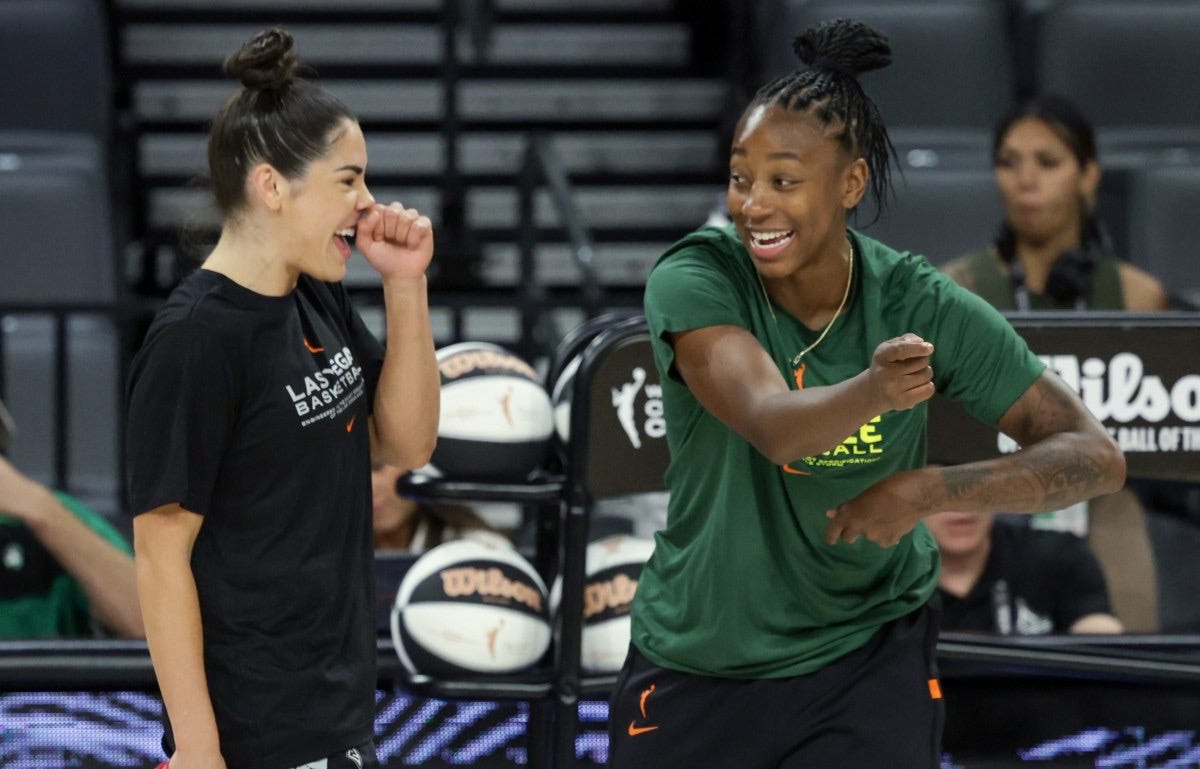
[994,216,1112,311]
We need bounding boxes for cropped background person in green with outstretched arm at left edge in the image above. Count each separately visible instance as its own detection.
[0,456,145,638]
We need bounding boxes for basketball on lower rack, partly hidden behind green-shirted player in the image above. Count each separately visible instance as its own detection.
[551,534,654,673]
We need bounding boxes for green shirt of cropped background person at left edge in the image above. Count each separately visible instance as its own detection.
[0,492,133,638]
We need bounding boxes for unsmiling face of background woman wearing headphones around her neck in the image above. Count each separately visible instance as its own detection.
[994,118,1100,244]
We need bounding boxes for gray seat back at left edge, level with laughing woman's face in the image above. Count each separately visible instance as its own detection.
[0,133,116,304]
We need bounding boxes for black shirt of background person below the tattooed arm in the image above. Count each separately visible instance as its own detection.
[938,523,1112,636]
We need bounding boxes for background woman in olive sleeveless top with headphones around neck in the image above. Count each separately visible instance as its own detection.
[942,95,1170,311]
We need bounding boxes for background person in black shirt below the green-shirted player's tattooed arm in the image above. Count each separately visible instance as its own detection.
[925,512,1124,636]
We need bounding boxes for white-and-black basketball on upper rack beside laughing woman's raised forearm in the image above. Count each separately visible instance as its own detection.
[432,342,553,482]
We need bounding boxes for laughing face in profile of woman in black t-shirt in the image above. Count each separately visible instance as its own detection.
[283,120,374,282]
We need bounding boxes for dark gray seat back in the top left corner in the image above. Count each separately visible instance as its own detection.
[0,0,112,142]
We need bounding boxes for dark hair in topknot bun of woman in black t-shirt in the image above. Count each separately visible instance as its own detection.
[209,26,354,218]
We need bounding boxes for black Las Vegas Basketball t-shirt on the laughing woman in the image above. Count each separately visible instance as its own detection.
[126,270,383,769]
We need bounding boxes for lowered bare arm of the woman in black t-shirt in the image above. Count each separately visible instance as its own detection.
[133,504,224,769]
